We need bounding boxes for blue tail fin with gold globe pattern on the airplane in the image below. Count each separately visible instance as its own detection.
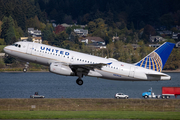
[135,42,175,72]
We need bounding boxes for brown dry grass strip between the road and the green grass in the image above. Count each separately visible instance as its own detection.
[0,99,180,112]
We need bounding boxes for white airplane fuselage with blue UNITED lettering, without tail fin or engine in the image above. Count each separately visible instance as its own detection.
[4,42,171,81]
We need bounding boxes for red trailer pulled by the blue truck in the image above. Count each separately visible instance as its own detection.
[162,87,180,99]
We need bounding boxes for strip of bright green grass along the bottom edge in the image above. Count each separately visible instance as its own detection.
[0,111,180,120]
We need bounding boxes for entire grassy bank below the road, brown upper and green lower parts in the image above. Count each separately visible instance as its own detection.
[0,98,180,119]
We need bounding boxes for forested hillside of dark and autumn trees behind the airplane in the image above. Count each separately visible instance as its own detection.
[0,0,180,69]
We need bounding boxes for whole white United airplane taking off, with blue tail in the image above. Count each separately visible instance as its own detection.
[4,41,175,85]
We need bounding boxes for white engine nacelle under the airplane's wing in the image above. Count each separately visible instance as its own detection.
[49,63,74,76]
